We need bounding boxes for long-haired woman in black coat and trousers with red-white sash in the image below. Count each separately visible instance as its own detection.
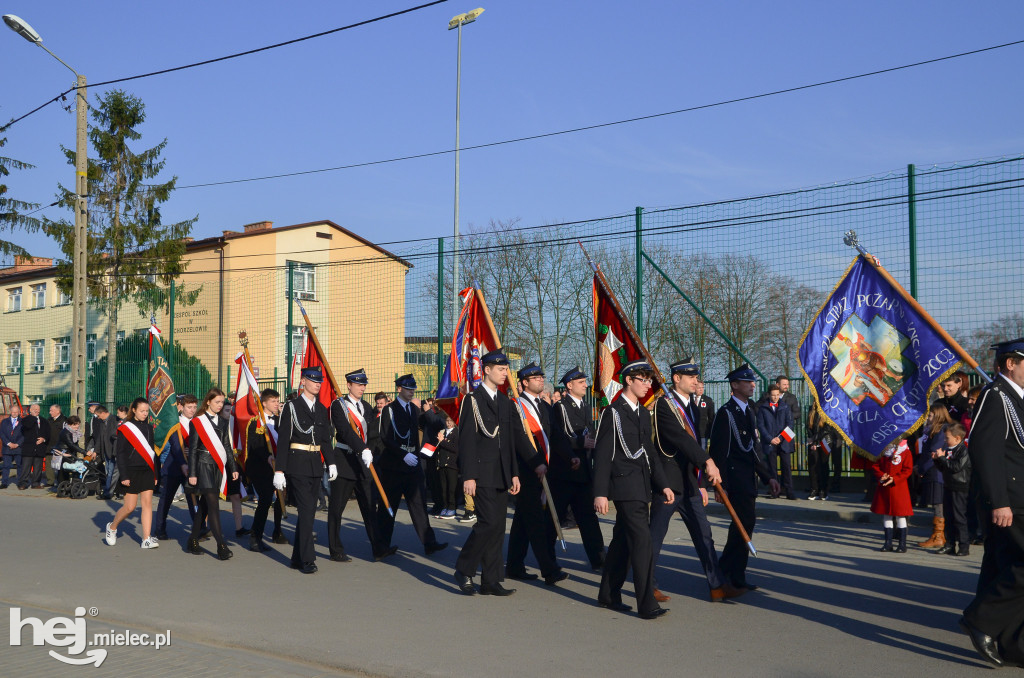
[187,388,239,560]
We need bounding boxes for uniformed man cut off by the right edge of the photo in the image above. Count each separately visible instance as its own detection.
[961,338,1024,666]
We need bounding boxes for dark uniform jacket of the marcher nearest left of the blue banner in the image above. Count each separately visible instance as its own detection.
[711,397,772,497]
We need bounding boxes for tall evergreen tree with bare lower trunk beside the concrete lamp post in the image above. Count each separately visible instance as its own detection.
[45,89,198,409]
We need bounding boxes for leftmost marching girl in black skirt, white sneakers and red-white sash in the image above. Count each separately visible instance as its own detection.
[105,397,160,549]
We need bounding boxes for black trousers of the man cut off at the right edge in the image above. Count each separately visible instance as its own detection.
[964,520,1024,664]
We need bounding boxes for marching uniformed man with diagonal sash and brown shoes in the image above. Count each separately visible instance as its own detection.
[650,357,742,602]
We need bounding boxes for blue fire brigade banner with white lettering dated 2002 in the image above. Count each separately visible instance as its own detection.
[798,256,962,460]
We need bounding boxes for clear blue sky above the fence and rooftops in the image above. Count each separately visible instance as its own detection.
[0,0,1024,256]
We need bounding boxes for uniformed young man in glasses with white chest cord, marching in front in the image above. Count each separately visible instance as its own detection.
[594,361,676,620]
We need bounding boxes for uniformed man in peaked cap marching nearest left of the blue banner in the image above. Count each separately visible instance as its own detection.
[711,364,779,591]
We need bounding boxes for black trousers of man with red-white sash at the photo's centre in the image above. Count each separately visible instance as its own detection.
[505,469,561,577]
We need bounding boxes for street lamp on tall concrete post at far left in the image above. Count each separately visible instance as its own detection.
[3,14,89,420]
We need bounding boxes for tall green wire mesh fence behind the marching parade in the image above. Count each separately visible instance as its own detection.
[0,156,1024,477]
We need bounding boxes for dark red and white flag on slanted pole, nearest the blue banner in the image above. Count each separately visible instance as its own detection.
[594,272,662,408]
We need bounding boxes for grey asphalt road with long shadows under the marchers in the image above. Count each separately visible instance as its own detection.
[0,489,1016,678]
